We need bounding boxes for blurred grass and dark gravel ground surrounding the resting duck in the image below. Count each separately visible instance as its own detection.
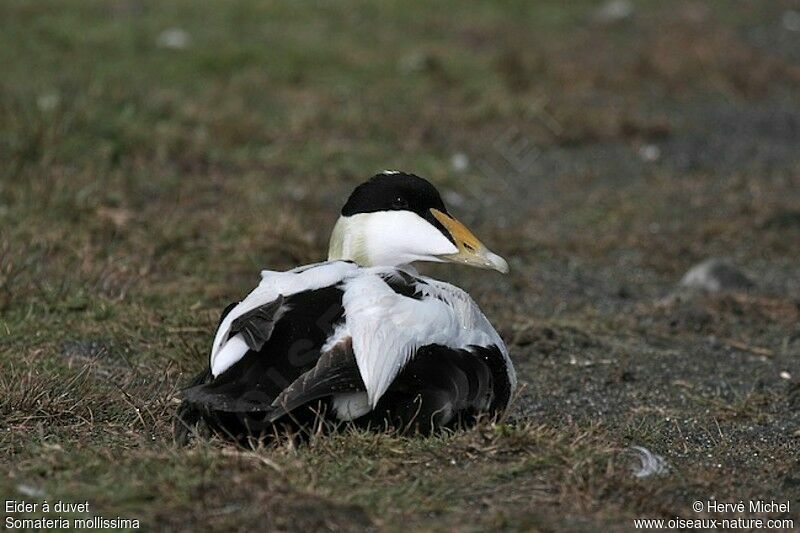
[0,0,800,530]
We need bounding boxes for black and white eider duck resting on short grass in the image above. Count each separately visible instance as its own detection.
[174,171,517,443]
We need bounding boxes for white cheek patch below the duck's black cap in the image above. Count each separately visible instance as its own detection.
[352,211,458,265]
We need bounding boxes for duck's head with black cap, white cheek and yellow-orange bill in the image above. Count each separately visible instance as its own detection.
[328,171,508,274]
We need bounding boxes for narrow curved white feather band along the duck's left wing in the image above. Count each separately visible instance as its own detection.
[209,261,358,377]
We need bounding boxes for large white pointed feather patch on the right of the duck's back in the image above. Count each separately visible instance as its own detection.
[338,268,515,408]
